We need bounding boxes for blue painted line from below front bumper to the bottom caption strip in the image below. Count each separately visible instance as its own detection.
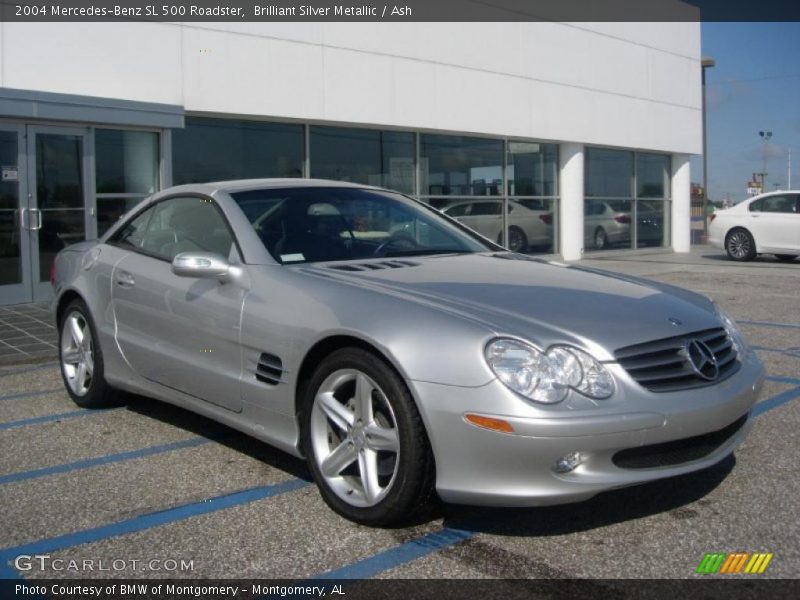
[311,527,477,580]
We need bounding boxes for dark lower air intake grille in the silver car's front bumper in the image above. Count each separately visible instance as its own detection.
[611,415,748,469]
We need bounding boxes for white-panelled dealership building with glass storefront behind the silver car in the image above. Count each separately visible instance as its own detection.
[0,22,702,304]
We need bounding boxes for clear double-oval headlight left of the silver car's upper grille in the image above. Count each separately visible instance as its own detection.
[485,338,614,404]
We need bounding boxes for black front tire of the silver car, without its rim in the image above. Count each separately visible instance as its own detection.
[300,348,433,526]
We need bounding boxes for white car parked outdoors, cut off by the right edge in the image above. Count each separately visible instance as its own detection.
[708,191,800,261]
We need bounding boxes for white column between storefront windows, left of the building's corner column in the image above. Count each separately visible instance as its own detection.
[558,143,583,260]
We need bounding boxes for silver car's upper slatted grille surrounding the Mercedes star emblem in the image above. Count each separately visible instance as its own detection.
[614,327,740,392]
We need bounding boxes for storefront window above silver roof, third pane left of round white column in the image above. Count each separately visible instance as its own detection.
[309,126,415,194]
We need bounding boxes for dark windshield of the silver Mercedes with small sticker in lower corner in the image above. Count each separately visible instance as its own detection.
[231,187,497,264]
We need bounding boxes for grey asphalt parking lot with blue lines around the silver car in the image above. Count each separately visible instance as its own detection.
[0,248,800,579]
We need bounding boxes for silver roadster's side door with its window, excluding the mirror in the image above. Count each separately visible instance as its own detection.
[110,196,246,412]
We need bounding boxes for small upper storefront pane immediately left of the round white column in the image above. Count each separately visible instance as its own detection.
[507,142,558,196]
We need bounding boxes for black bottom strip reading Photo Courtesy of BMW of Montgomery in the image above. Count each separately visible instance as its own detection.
[0,575,800,600]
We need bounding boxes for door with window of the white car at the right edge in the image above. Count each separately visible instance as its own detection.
[748,194,800,253]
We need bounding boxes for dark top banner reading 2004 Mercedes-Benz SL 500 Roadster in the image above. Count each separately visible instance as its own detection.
[0,0,800,22]
